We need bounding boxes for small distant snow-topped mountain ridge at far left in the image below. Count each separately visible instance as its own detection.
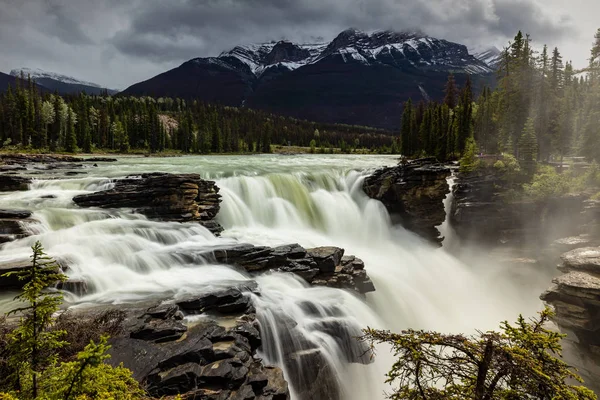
[10,67,116,94]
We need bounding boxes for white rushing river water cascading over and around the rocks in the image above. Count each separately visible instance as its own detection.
[0,156,548,400]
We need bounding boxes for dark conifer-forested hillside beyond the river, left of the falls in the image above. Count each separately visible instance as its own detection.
[0,79,392,154]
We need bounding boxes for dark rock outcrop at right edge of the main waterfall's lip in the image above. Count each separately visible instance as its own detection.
[363,158,451,244]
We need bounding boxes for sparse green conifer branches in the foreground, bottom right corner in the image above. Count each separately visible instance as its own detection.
[363,309,596,400]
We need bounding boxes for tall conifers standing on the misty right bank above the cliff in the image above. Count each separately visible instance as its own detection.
[399,30,600,161]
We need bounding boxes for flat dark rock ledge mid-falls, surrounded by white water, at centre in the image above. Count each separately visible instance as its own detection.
[188,244,375,294]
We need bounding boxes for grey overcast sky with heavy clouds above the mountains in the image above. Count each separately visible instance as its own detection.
[0,0,600,89]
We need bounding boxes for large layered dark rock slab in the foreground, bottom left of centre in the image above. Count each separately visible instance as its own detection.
[92,285,290,400]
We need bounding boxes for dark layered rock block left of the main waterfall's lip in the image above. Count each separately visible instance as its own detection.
[73,173,223,234]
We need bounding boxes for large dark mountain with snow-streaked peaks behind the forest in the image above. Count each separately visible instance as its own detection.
[123,29,494,129]
